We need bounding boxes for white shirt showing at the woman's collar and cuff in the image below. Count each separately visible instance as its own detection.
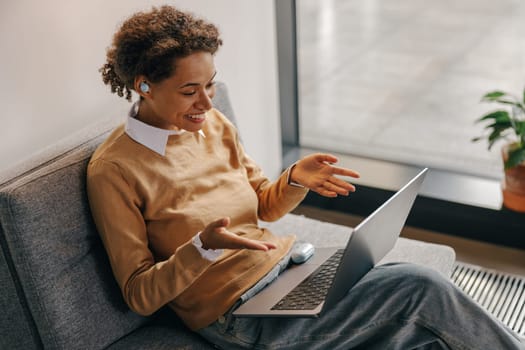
[126,101,219,261]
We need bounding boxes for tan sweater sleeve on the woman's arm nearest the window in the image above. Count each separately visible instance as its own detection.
[231,129,308,221]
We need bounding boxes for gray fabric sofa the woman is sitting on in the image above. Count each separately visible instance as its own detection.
[0,84,455,350]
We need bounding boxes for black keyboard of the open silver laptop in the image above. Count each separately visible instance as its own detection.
[272,249,344,310]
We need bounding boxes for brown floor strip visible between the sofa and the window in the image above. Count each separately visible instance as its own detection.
[294,205,525,277]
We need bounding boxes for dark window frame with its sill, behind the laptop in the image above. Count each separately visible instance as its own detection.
[275,0,525,249]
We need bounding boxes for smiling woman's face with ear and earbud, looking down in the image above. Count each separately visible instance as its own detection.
[135,52,216,132]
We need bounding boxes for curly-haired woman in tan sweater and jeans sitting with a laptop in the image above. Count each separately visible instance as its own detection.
[88,6,519,349]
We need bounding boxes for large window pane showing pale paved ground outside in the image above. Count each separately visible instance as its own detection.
[297,0,525,178]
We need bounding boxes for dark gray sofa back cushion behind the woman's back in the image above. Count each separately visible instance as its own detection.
[0,132,146,349]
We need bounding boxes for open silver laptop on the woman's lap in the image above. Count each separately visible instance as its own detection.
[233,168,428,317]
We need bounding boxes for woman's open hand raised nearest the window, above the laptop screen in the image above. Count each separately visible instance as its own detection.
[290,153,359,197]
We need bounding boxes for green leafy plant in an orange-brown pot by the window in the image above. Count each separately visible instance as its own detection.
[472,90,525,212]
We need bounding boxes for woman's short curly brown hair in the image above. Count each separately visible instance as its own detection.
[99,6,222,101]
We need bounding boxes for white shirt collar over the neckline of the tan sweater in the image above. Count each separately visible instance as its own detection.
[126,101,206,156]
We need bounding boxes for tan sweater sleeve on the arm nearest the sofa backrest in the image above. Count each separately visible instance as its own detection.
[87,159,213,315]
